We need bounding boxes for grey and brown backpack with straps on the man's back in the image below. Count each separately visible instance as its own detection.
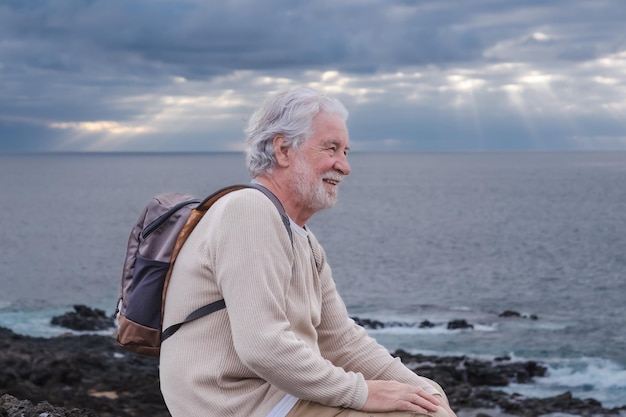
[113,184,293,356]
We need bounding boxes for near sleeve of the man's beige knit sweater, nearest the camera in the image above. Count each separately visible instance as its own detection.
[212,190,367,409]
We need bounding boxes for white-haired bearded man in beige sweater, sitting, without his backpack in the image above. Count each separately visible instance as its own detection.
[160,88,454,417]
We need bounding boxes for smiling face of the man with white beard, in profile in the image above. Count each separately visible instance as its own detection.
[292,113,350,213]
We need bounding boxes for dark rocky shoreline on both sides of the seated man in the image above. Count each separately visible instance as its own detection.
[0,307,626,417]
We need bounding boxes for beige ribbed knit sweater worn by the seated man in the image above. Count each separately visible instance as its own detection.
[160,189,436,417]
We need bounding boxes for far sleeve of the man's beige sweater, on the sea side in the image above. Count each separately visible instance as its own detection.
[311,235,438,394]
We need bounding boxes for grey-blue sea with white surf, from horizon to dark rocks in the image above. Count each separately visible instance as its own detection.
[0,152,626,407]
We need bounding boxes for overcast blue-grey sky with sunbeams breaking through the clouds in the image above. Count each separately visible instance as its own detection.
[0,0,626,152]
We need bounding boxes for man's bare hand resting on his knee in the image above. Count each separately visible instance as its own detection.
[361,380,442,415]
